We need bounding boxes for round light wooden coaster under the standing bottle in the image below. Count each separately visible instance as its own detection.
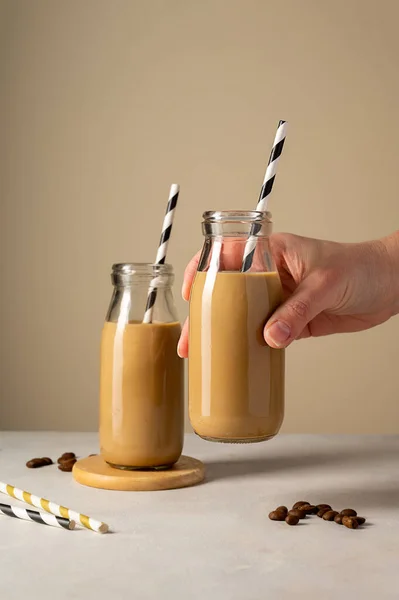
[72,456,205,492]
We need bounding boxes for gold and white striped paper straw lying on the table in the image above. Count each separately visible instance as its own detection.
[0,481,109,533]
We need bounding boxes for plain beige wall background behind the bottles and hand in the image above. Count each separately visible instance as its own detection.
[0,0,399,433]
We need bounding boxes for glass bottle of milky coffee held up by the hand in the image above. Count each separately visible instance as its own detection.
[188,211,285,443]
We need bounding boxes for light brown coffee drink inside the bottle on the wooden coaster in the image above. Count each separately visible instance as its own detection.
[100,323,184,468]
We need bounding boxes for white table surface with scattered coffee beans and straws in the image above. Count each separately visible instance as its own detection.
[0,432,399,600]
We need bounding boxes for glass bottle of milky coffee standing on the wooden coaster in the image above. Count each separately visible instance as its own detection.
[100,263,184,470]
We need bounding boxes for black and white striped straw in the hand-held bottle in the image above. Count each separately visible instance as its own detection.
[241,121,287,271]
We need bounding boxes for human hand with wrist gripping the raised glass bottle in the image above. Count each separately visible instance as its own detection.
[178,234,399,357]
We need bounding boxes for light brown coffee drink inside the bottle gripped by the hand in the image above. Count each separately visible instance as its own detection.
[189,272,285,442]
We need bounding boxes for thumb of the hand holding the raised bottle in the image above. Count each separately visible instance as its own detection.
[264,278,328,348]
